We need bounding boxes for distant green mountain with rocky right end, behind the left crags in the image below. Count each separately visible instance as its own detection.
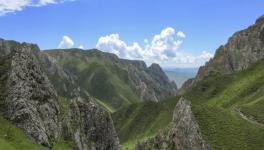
[42,49,177,112]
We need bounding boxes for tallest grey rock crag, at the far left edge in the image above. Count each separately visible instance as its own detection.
[0,40,59,147]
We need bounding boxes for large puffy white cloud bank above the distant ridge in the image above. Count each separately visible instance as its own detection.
[96,27,213,66]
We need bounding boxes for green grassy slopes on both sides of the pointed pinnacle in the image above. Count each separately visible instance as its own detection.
[113,61,264,150]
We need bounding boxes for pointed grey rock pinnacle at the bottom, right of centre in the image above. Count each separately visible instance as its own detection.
[136,98,210,150]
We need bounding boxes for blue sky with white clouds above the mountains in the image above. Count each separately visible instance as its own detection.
[0,0,264,68]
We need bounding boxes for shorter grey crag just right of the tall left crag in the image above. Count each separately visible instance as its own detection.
[62,98,120,150]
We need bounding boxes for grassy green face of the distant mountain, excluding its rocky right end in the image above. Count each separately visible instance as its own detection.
[44,49,139,112]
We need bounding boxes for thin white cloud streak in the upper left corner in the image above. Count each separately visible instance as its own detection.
[0,0,73,16]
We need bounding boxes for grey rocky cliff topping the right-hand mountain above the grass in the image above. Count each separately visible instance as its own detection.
[183,16,264,92]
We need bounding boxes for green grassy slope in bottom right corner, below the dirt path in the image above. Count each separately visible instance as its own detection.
[193,105,264,150]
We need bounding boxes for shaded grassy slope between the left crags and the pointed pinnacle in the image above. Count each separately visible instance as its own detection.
[112,98,177,149]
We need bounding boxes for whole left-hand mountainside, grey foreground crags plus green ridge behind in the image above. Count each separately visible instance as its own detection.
[0,39,177,150]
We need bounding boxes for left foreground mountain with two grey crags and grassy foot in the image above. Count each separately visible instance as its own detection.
[0,39,120,150]
